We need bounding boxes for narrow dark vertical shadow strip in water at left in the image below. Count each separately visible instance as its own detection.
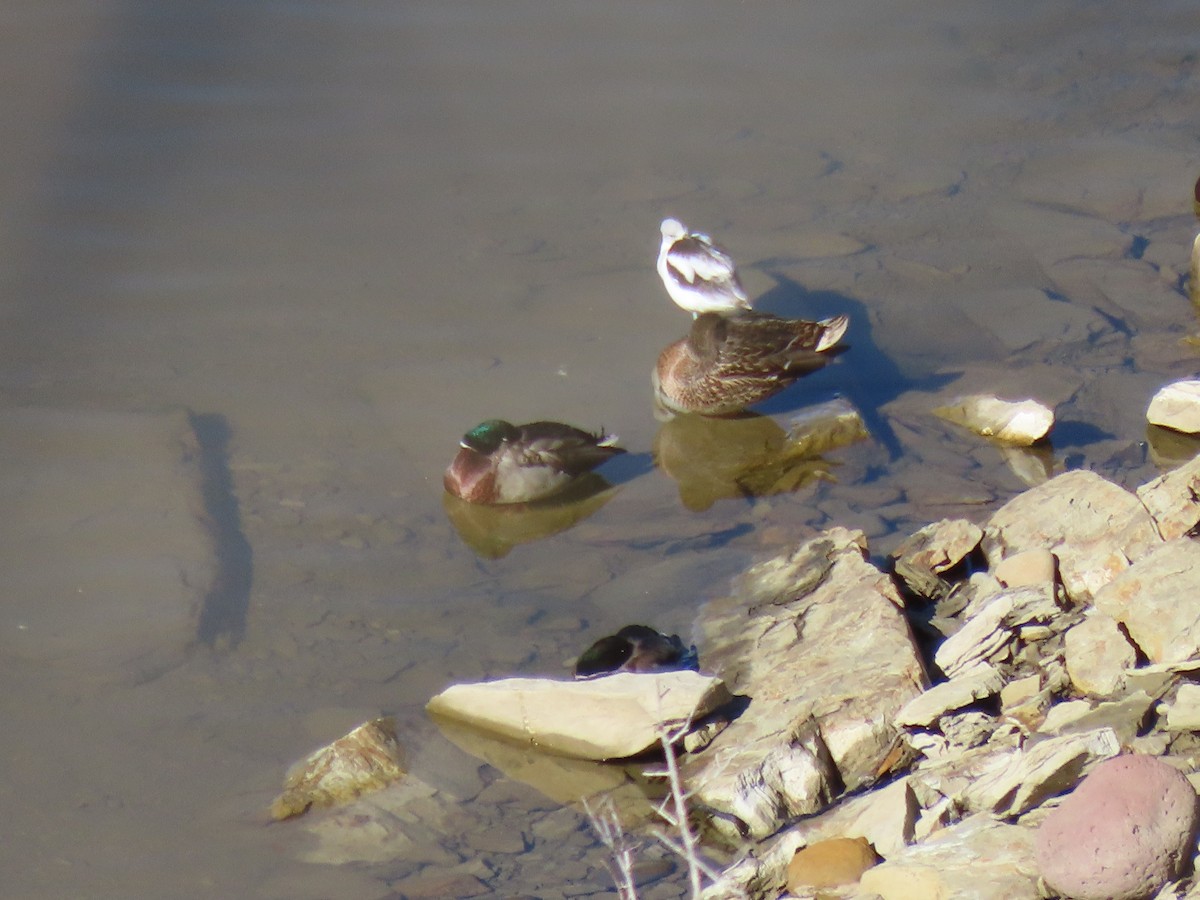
[187,413,254,649]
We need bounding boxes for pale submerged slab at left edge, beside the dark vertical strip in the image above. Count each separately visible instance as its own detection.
[0,409,218,677]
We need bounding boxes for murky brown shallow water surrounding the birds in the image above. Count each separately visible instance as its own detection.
[0,0,1200,898]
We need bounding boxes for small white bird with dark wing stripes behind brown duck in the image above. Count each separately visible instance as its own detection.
[659,218,750,316]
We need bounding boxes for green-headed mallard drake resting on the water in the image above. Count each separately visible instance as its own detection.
[442,419,625,503]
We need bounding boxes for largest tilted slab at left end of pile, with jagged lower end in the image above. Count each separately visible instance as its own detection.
[684,528,929,838]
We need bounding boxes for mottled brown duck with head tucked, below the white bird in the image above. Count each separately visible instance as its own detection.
[653,313,850,415]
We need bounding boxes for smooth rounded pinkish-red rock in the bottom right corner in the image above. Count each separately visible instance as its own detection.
[1034,755,1198,900]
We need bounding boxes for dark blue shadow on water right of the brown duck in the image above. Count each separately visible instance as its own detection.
[755,269,958,461]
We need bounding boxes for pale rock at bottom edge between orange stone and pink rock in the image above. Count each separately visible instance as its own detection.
[859,815,1039,900]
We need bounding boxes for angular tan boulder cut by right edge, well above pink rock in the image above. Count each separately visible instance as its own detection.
[1096,538,1200,662]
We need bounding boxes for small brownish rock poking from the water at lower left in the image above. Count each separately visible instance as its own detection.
[271,718,404,820]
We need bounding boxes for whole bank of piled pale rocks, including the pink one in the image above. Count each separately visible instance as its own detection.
[700,458,1200,900]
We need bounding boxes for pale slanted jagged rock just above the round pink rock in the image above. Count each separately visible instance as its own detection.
[962,728,1121,816]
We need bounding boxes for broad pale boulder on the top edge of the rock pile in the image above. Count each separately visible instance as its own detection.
[983,469,1162,604]
